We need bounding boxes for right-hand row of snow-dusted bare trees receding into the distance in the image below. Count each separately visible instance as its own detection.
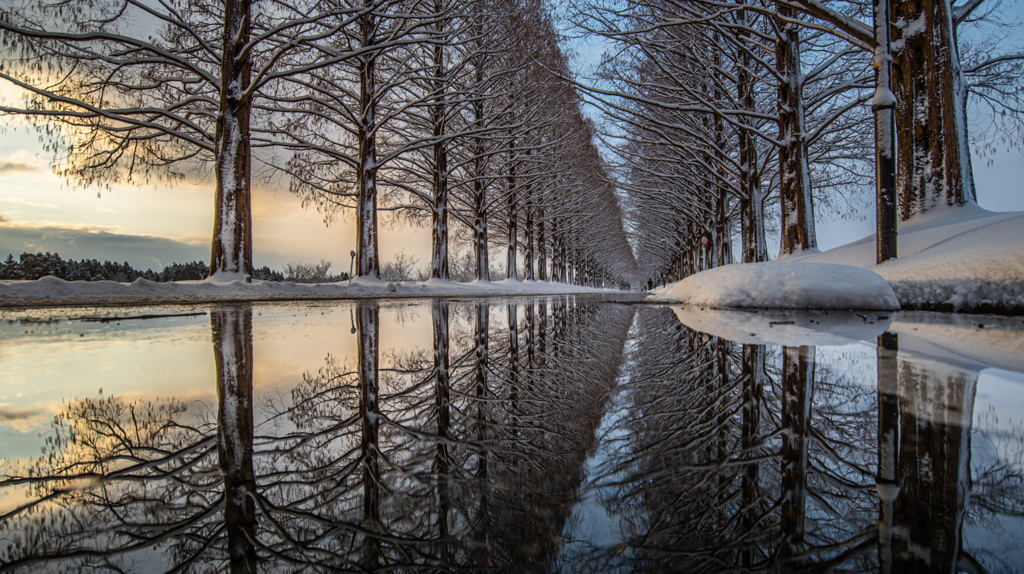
[575,0,1024,279]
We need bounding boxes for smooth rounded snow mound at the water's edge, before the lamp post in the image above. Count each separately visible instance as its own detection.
[652,260,899,310]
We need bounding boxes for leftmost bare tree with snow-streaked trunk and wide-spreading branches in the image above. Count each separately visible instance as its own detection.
[0,0,348,276]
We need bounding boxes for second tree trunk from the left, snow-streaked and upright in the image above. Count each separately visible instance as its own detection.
[355,0,380,277]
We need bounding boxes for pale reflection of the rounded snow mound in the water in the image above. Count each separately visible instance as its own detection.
[672,305,890,347]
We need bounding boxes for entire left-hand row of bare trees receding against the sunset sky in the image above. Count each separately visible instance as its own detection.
[0,0,635,283]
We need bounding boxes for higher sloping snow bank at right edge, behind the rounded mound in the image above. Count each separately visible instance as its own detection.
[788,206,1024,313]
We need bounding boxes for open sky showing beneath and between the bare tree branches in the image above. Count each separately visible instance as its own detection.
[0,6,1024,272]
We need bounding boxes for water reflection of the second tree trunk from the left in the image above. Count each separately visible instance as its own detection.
[355,301,381,570]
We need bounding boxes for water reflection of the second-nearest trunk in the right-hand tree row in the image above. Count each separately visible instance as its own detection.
[780,347,815,563]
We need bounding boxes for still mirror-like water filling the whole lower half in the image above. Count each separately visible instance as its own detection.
[0,298,1024,573]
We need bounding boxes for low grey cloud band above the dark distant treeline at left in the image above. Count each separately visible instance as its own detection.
[0,219,210,270]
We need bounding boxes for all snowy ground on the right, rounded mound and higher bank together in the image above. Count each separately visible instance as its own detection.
[653,206,1024,314]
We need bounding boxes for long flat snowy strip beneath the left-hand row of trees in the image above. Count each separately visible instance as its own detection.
[0,276,610,307]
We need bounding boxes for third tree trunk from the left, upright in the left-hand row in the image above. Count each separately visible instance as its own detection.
[430,0,449,279]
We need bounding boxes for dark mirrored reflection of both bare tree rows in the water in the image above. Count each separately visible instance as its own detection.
[0,299,1024,572]
